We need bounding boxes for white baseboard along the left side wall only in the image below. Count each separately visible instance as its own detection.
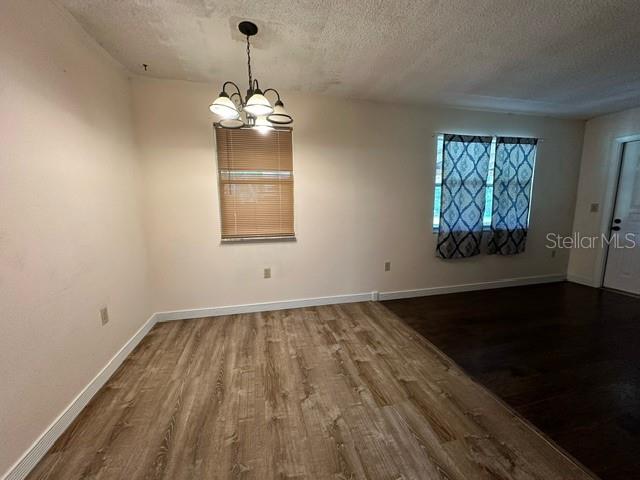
[2,314,156,480]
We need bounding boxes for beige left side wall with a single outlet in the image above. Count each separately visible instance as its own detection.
[0,0,150,477]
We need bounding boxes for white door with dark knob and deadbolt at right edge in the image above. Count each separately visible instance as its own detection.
[604,141,640,295]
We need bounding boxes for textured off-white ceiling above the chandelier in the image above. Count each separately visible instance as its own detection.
[55,0,640,118]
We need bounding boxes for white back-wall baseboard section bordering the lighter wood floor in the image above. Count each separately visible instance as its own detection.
[156,292,378,322]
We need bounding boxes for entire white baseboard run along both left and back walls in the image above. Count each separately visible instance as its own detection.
[2,275,568,480]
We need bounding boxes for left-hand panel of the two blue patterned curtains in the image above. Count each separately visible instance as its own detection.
[436,135,491,258]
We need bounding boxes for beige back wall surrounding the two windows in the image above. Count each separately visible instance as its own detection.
[133,78,583,310]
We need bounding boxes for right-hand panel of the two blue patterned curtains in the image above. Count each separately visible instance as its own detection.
[489,137,538,255]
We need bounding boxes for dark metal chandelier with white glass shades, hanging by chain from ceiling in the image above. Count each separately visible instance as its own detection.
[209,21,293,132]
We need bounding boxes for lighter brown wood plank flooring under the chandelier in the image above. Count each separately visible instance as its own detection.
[28,302,593,480]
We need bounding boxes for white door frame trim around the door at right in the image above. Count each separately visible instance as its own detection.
[594,133,640,287]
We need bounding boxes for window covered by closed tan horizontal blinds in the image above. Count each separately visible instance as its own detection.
[215,127,294,240]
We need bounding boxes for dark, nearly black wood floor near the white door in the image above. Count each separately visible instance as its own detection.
[384,283,640,480]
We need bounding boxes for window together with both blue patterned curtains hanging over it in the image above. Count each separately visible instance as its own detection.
[432,133,538,259]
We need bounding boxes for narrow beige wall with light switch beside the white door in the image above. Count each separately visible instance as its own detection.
[568,108,640,286]
